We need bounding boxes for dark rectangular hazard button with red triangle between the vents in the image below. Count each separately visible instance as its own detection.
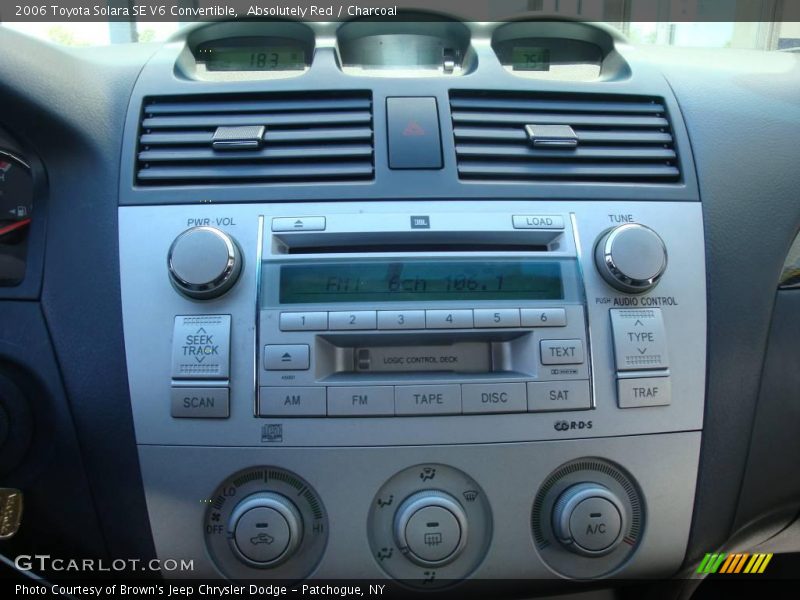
[386,97,442,169]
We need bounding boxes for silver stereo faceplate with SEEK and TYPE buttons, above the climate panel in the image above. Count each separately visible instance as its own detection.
[120,201,706,447]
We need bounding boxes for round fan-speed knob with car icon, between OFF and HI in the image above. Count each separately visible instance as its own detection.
[228,492,303,568]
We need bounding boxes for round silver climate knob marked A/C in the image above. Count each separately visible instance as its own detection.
[553,483,625,556]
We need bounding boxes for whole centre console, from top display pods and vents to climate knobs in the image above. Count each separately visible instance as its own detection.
[119,16,706,588]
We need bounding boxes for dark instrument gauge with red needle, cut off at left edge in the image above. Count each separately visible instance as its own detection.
[0,150,33,286]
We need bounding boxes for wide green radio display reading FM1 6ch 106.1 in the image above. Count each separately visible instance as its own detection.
[279,261,564,304]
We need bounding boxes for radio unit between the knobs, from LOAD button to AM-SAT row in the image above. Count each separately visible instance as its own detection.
[257,214,592,417]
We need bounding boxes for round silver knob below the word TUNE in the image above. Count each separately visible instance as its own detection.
[594,223,667,294]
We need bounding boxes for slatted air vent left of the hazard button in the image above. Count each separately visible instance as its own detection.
[136,92,374,186]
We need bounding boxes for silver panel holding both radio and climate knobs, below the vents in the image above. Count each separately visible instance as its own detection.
[120,200,705,585]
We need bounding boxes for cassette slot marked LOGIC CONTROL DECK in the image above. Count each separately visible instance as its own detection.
[316,331,531,381]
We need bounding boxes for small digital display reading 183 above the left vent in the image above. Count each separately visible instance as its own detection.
[201,46,306,71]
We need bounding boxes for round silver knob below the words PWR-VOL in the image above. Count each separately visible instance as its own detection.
[167,227,242,300]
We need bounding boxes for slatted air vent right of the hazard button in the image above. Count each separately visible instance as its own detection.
[450,91,680,183]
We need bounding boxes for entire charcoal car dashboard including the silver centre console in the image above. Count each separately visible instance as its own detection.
[0,15,800,594]
